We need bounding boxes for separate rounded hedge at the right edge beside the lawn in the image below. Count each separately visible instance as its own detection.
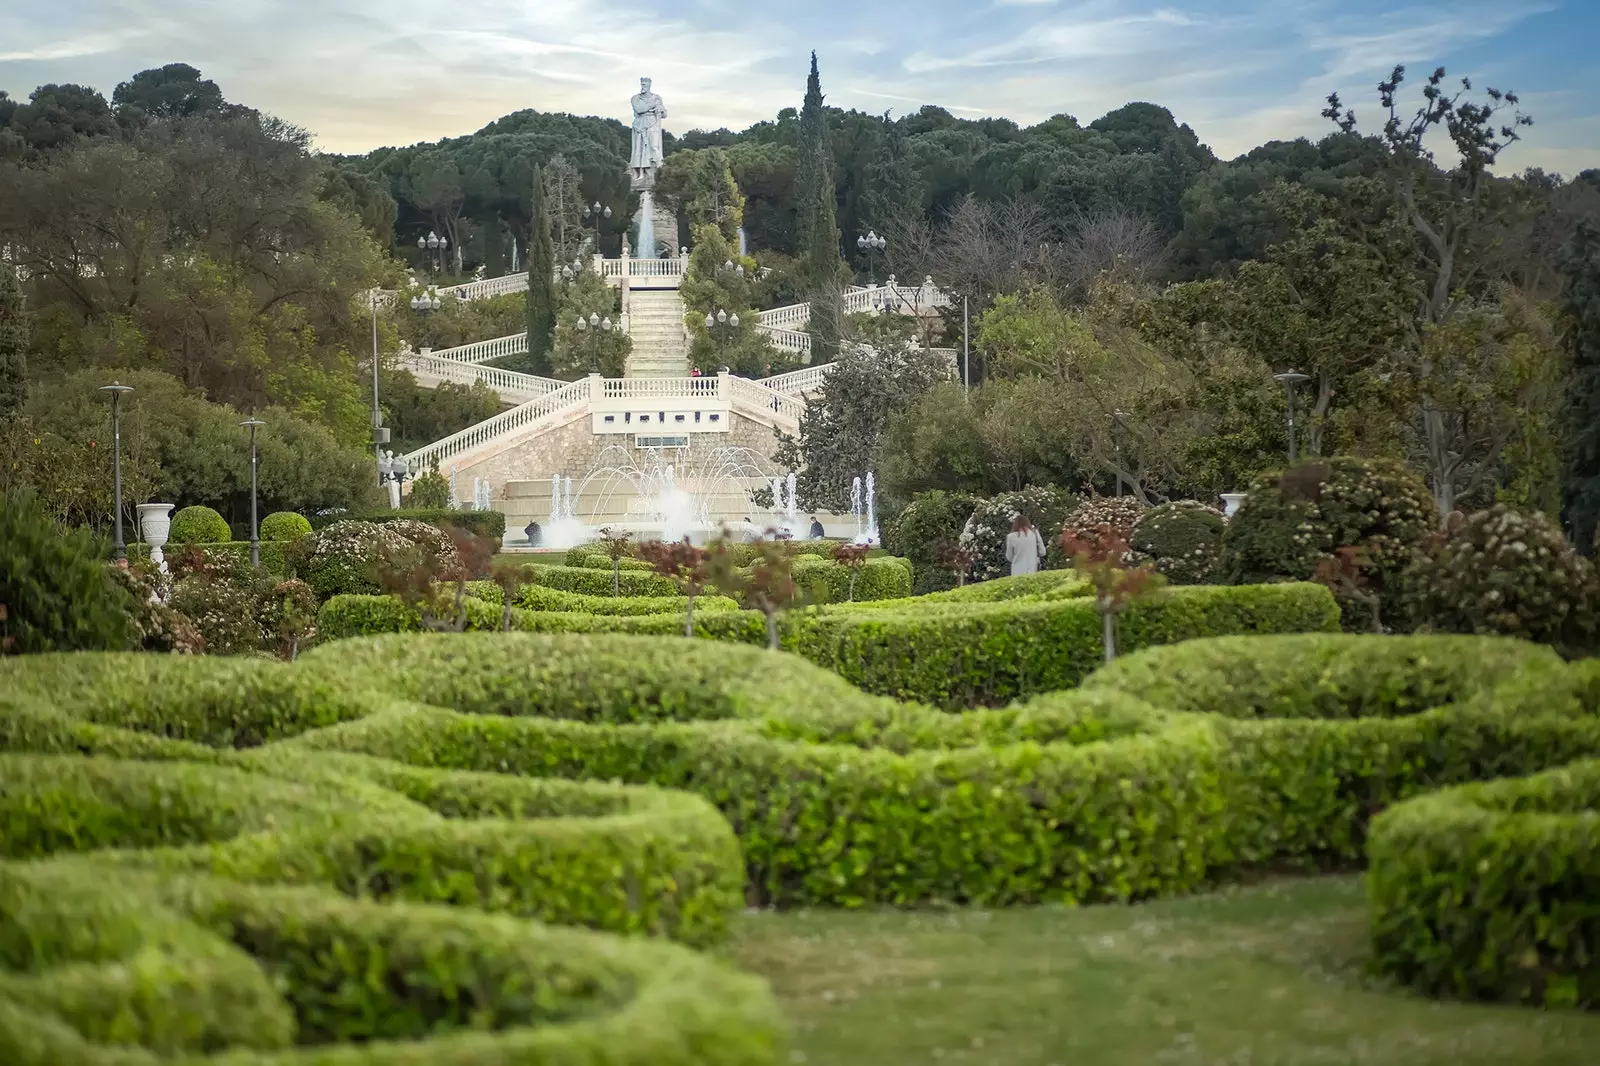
[1368,759,1600,1008]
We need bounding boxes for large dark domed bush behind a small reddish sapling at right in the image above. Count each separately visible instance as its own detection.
[1222,456,1438,624]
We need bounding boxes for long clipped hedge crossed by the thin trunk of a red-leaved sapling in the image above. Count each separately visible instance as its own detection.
[784,584,1339,707]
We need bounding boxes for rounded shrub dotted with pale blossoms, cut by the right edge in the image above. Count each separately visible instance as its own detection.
[1406,504,1600,651]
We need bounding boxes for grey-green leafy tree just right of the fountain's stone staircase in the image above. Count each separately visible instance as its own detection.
[778,317,950,512]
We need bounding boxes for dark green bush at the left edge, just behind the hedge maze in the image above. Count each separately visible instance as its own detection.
[0,493,131,655]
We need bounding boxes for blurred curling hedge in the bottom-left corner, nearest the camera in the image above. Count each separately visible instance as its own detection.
[0,860,779,1066]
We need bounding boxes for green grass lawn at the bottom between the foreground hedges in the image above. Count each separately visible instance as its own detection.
[730,877,1600,1066]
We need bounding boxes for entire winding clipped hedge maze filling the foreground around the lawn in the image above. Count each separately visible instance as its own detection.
[0,634,1600,1066]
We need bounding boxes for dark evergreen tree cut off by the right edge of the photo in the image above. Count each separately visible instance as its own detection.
[1562,219,1600,552]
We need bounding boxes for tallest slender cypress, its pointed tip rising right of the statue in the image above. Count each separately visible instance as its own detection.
[795,51,845,363]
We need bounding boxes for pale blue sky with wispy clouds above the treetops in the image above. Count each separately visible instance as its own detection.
[0,0,1600,176]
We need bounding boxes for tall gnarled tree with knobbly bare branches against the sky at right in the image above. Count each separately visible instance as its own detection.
[1322,66,1533,519]
